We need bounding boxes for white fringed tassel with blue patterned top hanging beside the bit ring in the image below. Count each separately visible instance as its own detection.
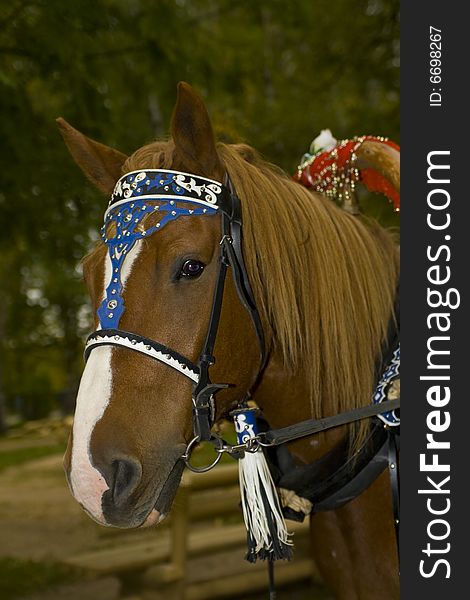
[232,408,292,562]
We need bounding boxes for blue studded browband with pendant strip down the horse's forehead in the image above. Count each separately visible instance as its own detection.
[97,169,229,329]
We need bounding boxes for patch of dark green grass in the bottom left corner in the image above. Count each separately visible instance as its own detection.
[0,556,82,600]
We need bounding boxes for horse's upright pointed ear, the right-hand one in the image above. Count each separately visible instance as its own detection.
[171,81,224,179]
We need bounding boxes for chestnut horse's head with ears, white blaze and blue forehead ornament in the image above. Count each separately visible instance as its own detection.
[58,83,260,527]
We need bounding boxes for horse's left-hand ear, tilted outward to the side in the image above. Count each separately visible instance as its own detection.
[56,117,127,194]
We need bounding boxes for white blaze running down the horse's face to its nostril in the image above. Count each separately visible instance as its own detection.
[70,240,142,523]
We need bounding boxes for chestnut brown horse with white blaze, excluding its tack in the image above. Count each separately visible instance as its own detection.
[59,83,399,600]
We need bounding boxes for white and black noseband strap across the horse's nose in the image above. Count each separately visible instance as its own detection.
[85,329,199,383]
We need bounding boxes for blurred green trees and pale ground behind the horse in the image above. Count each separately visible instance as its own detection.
[0,0,399,600]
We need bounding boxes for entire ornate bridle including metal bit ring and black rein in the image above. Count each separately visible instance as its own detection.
[85,169,400,472]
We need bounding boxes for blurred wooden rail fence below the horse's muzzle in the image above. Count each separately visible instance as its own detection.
[66,464,316,600]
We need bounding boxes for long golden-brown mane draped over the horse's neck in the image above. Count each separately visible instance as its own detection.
[123,142,399,446]
